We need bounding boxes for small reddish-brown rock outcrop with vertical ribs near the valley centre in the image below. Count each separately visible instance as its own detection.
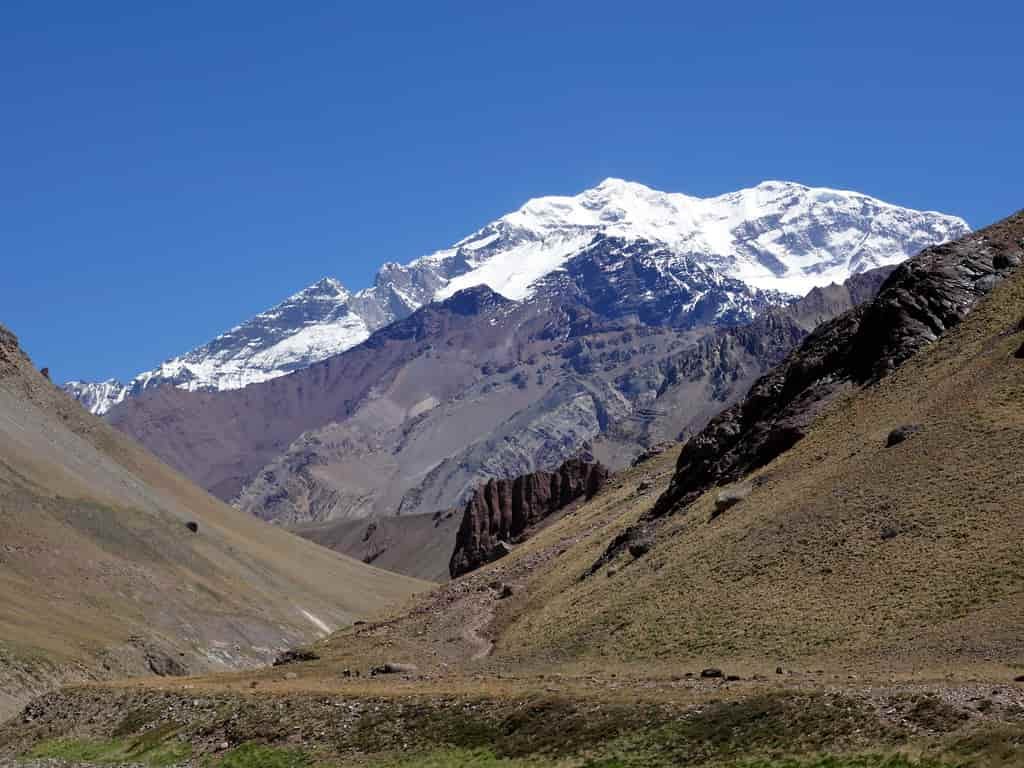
[449,458,608,578]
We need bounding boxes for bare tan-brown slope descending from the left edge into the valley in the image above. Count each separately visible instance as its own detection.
[0,328,422,712]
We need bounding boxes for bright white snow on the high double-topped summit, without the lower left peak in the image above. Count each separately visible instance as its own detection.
[430,178,970,300]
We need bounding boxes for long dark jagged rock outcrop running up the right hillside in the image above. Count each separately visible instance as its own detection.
[648,213,1024,519]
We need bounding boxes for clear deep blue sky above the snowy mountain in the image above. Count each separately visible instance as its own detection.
[0,0,1024,380]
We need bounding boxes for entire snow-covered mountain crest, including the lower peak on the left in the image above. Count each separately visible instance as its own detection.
[66,178,970,414]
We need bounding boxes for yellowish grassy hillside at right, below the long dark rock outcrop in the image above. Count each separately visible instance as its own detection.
[496,231,1024,677]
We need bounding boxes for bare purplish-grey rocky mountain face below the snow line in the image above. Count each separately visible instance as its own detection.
[110,262,891,524]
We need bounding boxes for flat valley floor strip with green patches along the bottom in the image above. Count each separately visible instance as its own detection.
[0,663,1024,768]
